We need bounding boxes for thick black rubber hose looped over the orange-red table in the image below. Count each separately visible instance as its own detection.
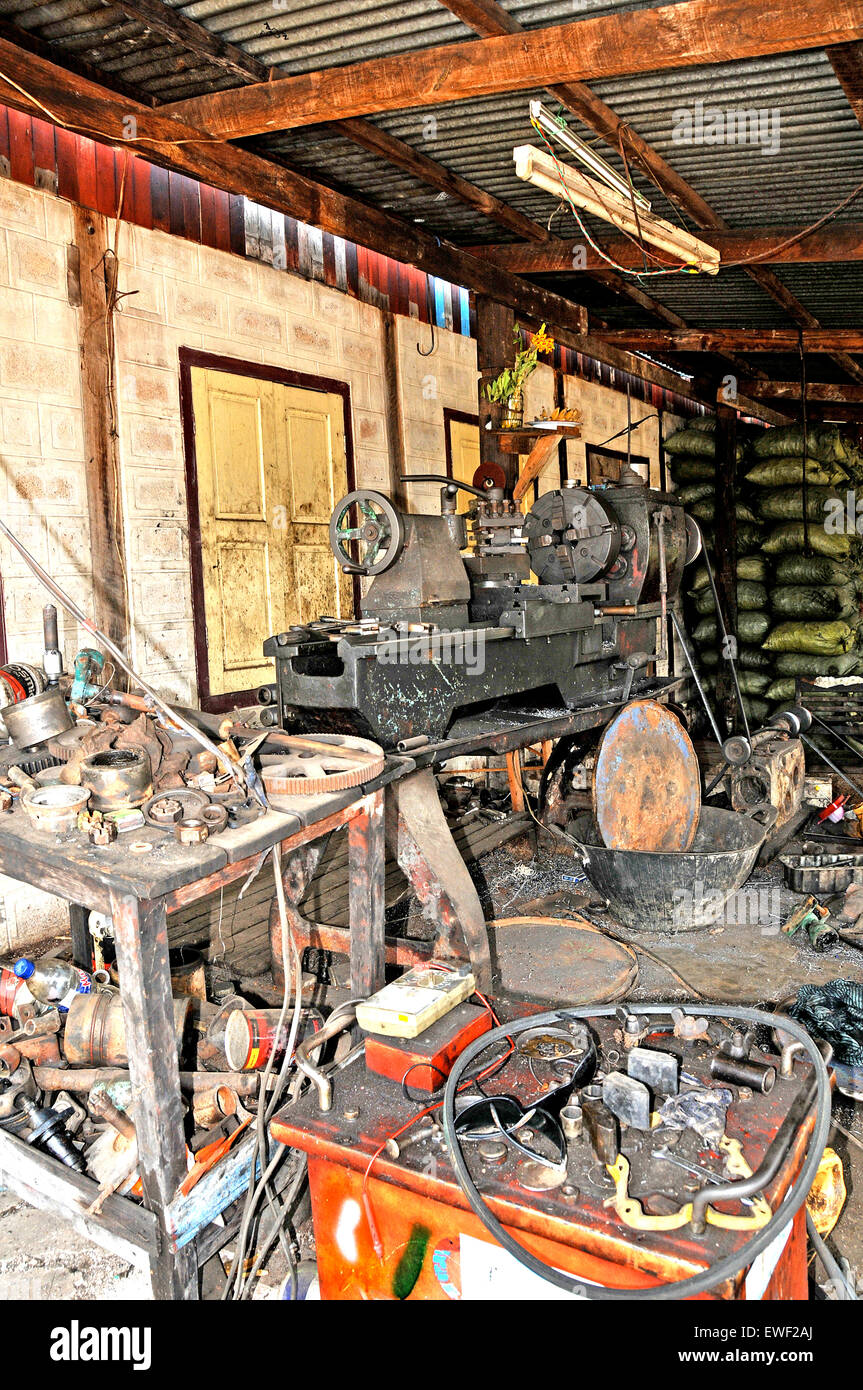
[443,1001,830,1302]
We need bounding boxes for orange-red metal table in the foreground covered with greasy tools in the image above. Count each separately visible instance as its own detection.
[272,1005,814,1300]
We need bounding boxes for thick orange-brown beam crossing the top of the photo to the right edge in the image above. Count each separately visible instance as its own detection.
[156,0,863,139]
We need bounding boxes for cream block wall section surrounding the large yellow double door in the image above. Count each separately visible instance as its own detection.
[117,225,389,703]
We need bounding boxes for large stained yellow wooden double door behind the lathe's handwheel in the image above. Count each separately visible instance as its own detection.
[192,367,352,695]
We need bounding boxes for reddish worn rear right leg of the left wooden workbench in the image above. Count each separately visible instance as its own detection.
[347,790,386,999]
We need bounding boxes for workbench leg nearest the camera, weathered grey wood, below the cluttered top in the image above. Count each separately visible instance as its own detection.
[111,894,199,1300]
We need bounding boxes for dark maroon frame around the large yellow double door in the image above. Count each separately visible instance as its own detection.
[179,348,359,714]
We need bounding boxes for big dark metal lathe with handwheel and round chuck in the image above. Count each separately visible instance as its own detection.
[261,475,687,748]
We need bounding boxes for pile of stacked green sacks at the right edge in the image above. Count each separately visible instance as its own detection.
[666,420,863,721]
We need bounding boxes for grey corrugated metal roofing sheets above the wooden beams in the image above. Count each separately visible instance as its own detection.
[0,0,863,341]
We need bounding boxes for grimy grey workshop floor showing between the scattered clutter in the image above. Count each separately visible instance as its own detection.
[0,835,863,1301]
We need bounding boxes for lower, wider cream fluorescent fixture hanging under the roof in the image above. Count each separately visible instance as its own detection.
[513,145,720,275]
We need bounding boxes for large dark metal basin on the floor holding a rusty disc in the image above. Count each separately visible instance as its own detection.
[567,806,775,931]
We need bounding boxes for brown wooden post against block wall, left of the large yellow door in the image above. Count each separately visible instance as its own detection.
[72,204,129,681]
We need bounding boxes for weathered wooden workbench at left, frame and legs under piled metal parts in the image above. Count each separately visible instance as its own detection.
[0,759,403,1300]
